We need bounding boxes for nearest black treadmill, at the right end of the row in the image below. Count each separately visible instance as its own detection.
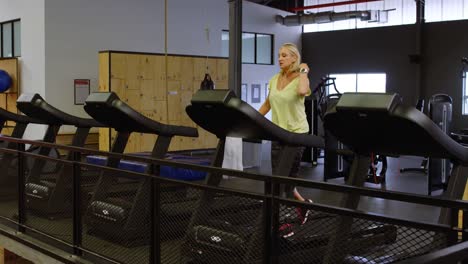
[323,93,468,263]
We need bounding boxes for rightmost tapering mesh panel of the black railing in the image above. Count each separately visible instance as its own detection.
[277,200,447,264]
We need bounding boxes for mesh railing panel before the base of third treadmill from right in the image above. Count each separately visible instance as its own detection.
[82,165,151,263]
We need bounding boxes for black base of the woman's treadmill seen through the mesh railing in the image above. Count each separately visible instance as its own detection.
[178,191,265,264]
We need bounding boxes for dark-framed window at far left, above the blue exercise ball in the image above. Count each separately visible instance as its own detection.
[0,20,21,58]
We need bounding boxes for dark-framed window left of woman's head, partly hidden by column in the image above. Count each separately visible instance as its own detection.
[221,30,273,65]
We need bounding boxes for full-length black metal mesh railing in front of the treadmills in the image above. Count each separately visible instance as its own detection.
[0,138,466,264]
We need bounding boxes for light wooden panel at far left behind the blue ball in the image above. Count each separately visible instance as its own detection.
[0,58,19,135]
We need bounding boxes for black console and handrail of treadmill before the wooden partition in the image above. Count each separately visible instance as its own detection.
[84,92,198,137]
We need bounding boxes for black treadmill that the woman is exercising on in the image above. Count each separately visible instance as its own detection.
[182,90,396,263]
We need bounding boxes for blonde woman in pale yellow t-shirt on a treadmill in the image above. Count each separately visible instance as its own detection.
[258,43,312,224]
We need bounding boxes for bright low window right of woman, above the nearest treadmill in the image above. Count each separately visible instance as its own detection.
[327,73,387,94]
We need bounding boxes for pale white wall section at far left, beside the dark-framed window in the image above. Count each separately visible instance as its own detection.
[0,0,45,138]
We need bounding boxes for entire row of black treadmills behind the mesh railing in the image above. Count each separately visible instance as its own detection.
[0,90,468,263]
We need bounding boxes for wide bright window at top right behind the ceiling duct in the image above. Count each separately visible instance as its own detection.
[304,0,416,32]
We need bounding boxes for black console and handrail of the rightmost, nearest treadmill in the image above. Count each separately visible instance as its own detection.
[324,93,468,164]
